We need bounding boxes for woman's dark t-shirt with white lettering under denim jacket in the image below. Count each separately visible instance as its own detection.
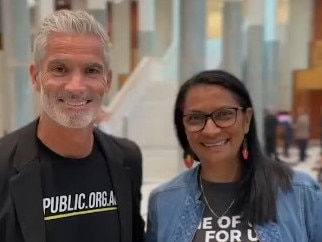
[193,179,258,242]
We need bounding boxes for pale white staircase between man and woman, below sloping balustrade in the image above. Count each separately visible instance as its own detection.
[127,81,181,183]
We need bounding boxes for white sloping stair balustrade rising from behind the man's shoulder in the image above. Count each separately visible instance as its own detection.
[104,41,178,137]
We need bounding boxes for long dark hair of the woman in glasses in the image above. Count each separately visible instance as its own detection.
[174,70,292,224]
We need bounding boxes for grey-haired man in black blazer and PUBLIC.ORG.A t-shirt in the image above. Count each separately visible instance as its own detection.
[0,10,144,242]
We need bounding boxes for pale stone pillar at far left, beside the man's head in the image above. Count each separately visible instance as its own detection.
[2,0,34,132]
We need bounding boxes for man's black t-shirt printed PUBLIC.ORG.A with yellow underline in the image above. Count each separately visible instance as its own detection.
[39,140,120,242]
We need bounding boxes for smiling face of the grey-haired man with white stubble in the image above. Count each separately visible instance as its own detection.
[30,33,111,128]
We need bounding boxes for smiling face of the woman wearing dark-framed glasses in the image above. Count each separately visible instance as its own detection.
[183,85,252,163]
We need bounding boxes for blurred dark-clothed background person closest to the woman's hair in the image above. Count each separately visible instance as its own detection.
[264,107,280,161]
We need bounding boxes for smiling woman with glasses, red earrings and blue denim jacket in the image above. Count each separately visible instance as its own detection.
[147,70,322,242]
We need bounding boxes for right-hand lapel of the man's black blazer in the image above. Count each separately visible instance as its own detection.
[95,130,133,242]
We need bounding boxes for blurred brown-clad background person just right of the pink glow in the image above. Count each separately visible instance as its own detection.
[294,107,310,162]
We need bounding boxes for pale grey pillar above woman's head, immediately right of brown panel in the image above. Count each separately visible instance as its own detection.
[222,0,243,78]
